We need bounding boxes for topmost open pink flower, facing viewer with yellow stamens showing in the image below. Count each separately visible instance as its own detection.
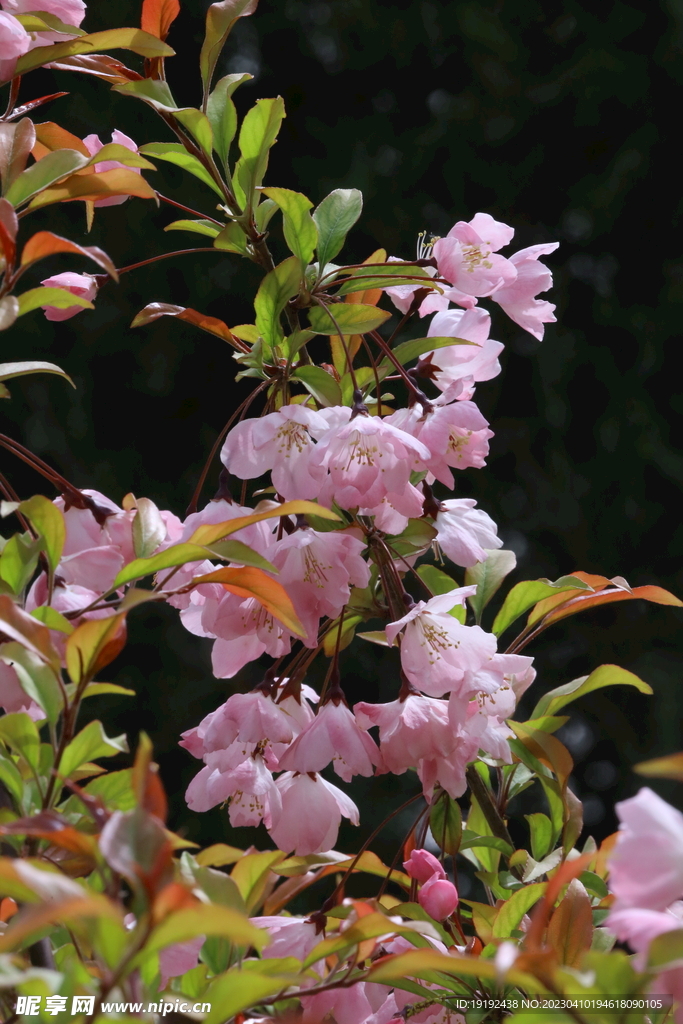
[433,213,517,306]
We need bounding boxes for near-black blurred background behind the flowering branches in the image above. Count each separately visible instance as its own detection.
[2,0,683,872]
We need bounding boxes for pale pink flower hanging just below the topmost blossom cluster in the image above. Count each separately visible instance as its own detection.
[420,306,504,400]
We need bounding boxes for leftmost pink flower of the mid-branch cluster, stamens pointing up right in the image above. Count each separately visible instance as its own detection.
[220,406,325,500]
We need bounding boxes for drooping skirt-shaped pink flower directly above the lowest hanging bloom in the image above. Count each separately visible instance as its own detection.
[280,698,380,782]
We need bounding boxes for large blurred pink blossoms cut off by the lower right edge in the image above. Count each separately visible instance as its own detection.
[605,787,683,1024]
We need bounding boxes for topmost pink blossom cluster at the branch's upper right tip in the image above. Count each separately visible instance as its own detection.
[387,213,559,342]
